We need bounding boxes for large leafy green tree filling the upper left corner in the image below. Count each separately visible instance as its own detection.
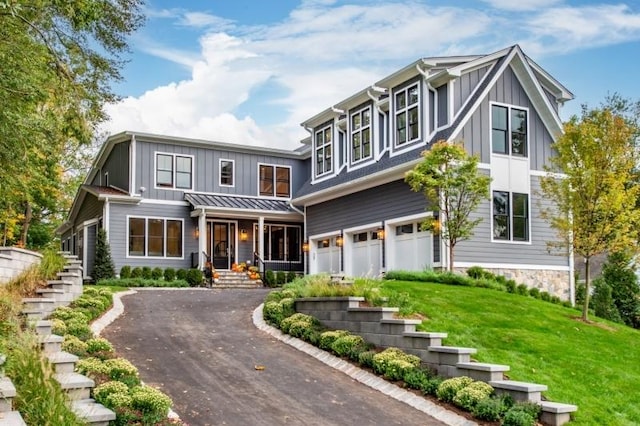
[0,0,143,243]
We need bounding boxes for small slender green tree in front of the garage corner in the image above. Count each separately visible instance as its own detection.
[405,141,491,271]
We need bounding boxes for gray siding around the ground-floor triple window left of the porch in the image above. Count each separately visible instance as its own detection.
[109,202,198,271]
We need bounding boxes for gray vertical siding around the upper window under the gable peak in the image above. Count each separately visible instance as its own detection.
[457,66,553,170]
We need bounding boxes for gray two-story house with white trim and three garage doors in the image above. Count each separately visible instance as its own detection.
[60,46,573,298]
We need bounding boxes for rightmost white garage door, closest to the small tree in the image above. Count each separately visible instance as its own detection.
[392,222,433,271]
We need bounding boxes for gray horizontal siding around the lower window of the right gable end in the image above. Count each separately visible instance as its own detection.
[455,176,569,267]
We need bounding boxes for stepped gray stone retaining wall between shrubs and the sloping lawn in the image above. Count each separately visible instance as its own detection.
[295,297,578,426]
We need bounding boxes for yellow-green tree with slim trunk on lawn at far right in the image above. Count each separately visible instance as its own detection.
[541,105,640,321]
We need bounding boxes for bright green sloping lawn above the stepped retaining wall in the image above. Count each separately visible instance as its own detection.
[383,281,640,426]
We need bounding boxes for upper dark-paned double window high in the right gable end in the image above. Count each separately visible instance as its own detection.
[491,105,527,157]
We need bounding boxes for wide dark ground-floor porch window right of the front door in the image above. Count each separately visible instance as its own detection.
[254,224,302,262]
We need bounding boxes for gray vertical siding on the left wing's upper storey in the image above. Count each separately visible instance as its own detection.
[136,138,308,201]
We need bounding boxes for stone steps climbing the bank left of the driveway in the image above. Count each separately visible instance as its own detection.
[11,254,116,426]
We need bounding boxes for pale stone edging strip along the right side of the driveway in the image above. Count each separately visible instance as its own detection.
[253,304,478,426]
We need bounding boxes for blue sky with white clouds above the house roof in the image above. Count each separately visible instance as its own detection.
[105,0,640,148]
